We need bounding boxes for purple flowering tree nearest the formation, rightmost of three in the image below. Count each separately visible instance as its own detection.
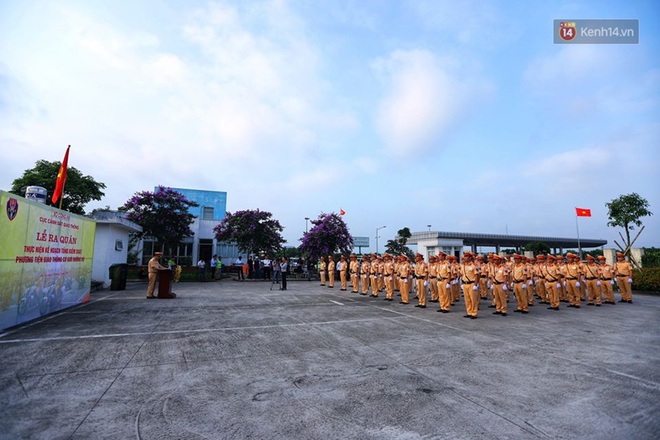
[300,213,353,261]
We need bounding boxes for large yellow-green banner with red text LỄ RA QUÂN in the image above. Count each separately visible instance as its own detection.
[0,191,96,330]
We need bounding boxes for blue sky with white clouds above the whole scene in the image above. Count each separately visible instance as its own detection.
[0,0,660,249]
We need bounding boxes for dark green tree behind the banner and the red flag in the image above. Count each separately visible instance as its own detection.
[9,160,105,215]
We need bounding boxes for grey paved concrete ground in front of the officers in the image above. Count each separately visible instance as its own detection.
[0,280,660,440]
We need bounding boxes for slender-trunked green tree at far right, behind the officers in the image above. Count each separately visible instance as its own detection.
[605,193,653,255]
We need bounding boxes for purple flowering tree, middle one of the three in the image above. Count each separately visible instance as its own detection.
[213,209,285,254]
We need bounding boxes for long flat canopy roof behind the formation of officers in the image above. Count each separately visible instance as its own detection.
[408,231,607,249]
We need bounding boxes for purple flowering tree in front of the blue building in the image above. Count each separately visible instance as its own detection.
[119,186,199,249]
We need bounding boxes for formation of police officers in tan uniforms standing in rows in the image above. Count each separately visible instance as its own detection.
[319,252,633,319]
